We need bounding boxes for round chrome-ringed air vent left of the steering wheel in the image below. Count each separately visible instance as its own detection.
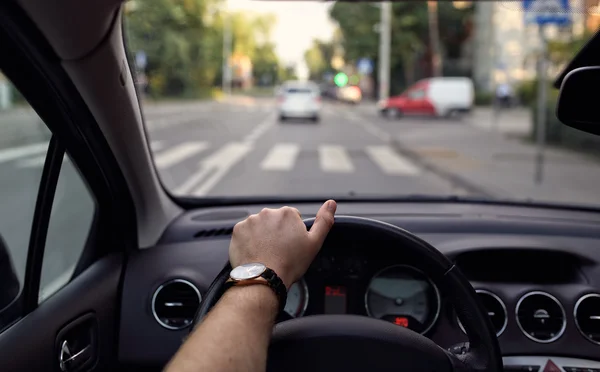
[152,279,202,330]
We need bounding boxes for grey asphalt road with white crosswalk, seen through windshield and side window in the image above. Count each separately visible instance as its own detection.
[0,98,465,304]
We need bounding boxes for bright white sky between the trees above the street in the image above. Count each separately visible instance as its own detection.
[227,0,335,77]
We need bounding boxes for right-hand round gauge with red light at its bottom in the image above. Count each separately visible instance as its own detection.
[365,265,440,333]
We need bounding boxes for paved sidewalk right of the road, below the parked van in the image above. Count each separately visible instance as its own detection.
[393,110,600,205]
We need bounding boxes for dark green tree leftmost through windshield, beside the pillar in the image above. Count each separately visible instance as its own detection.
[126,0,221,96]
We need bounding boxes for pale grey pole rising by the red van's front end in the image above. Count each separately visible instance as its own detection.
[379,1,392,100]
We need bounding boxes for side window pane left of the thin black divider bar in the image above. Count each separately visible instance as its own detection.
[0,72,51,316]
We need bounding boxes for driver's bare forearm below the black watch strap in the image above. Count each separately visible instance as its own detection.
[166,285,278,372]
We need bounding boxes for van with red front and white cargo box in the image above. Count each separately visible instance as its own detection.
[379,77,475,117]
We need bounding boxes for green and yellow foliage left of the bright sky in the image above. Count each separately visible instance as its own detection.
[125,0,280,98]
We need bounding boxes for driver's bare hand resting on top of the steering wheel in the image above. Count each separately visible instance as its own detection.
[229,200,337,288]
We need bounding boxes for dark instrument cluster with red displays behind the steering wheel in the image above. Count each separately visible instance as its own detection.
[279,255,441,334]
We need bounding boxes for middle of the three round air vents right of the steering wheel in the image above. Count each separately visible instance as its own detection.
[517,292,567,343]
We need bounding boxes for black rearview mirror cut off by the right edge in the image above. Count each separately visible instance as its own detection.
[556,66,600,135]
